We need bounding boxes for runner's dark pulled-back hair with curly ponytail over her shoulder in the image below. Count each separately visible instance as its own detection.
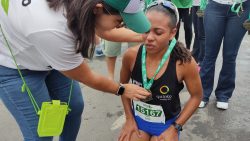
[147,4,192,64]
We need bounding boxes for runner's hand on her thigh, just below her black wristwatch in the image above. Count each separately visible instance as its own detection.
[157,126,178,141]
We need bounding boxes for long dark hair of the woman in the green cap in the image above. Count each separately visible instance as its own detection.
[47,0,119,58]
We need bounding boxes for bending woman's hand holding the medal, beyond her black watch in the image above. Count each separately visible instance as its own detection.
[122,84,151,100]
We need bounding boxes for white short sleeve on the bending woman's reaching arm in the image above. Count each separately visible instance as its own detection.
[27,30,83,71]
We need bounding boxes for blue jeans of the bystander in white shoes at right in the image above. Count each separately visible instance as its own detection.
[200,0,250,102]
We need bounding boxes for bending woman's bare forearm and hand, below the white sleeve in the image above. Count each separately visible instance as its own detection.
[61,61,149,99]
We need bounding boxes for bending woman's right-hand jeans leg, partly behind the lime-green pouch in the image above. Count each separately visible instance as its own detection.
[45,70,84,141]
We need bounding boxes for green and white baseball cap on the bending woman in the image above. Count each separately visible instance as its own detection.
[104,0,151,33]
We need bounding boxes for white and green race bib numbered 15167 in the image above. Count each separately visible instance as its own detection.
[133,101,165,124]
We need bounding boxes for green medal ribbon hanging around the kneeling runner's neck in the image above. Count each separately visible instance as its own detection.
[141,38,177,91]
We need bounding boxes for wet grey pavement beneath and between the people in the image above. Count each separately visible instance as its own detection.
[0,32,250,141]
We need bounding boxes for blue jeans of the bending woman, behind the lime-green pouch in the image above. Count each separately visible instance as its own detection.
[0,66,84,141]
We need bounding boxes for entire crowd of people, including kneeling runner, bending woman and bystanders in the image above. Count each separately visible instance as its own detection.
[0,0,250,141]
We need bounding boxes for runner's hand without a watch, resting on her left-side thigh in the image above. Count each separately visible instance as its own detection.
[118,119,141,141]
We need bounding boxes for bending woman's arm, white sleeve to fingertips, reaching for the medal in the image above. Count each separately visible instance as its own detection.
[27,29,149,99]
